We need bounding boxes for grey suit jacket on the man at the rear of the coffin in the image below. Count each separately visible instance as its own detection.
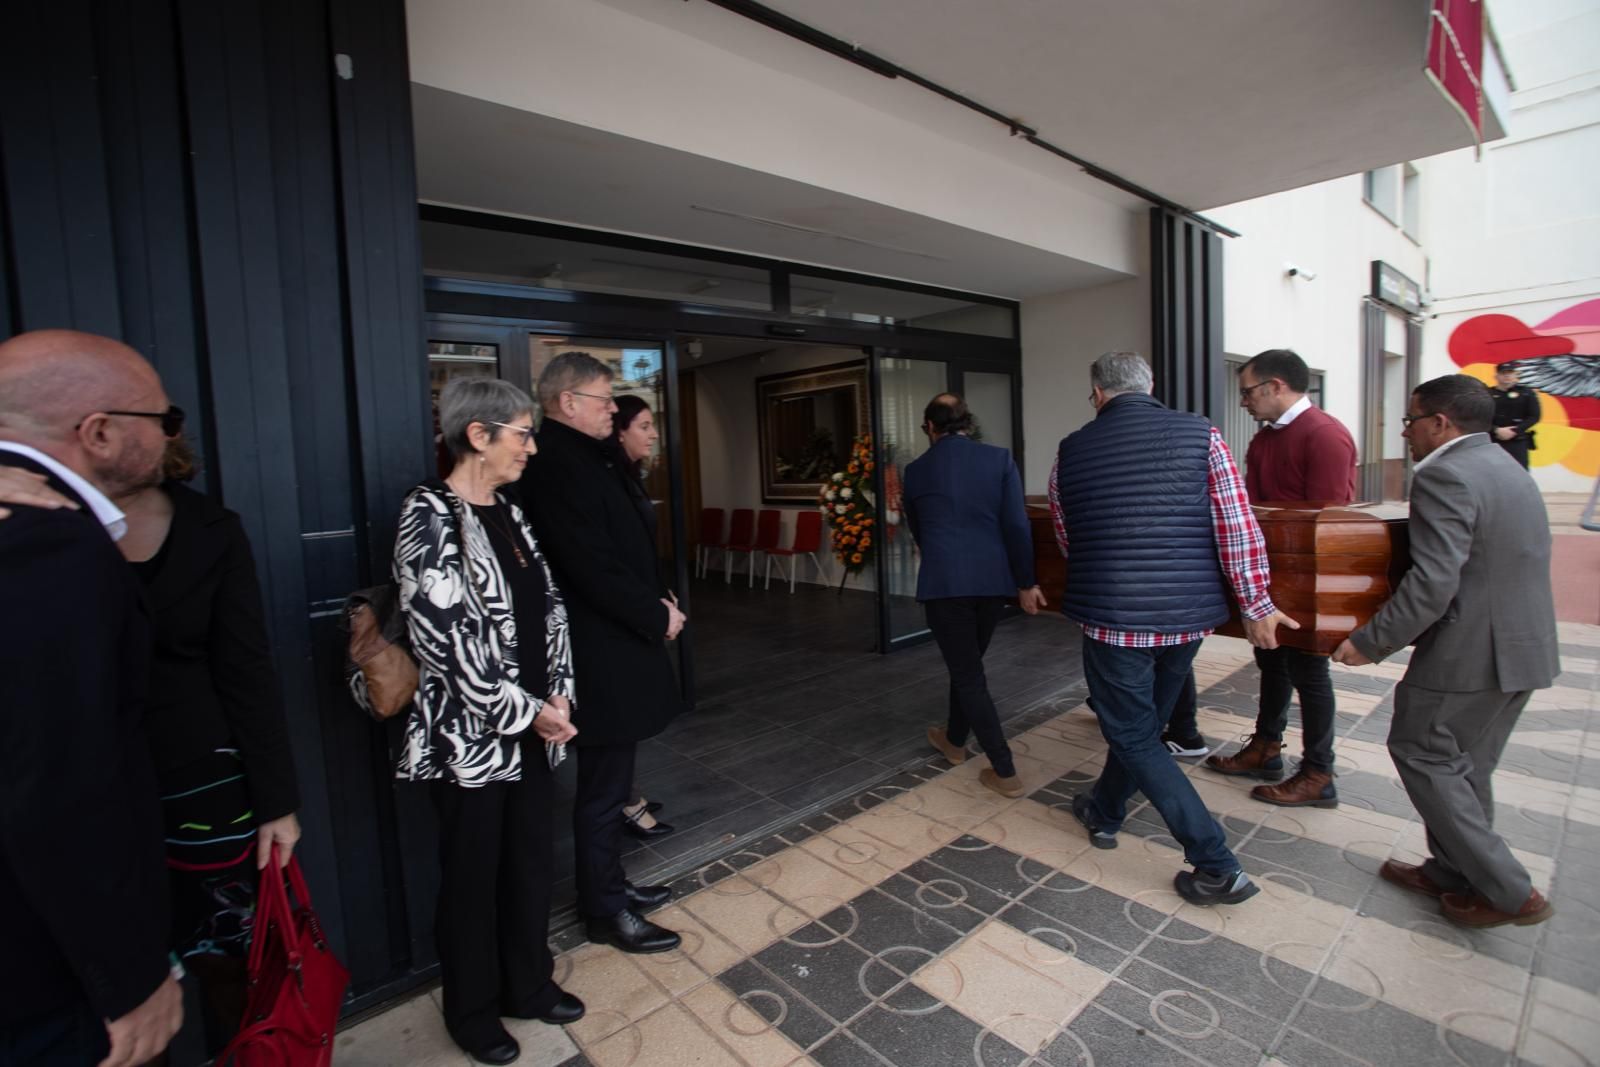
[1350,434,1562,693]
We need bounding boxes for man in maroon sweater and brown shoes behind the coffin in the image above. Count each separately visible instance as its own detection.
[1206,349,1355,808]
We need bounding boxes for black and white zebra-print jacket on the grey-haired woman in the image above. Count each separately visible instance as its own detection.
[394,482,576,785]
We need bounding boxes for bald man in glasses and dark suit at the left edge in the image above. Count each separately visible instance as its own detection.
[0,330,182,1067]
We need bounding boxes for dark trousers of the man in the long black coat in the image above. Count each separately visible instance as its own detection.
[573,741,638,918]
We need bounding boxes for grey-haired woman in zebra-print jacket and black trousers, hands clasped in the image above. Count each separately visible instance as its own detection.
[394,378,584,1064]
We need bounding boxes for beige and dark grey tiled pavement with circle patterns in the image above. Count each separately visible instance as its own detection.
[334,624,1600,1067]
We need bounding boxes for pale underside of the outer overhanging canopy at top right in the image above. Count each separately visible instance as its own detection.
[646,0,1502,210]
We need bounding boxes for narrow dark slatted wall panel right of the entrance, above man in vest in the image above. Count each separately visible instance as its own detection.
[1150,208,1234,422]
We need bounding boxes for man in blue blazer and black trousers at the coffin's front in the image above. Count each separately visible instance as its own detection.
[901,394,1045,797]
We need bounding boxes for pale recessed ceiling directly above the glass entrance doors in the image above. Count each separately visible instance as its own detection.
[411,83,1126,299]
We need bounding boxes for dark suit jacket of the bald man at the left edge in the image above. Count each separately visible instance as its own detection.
[0,507,168,1019]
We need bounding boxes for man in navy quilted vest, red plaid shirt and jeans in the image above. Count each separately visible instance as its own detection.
[1050,352,1299,904]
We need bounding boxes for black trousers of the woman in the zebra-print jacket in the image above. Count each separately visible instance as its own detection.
[430,748,562,1048]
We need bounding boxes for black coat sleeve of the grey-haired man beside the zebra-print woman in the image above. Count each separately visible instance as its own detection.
[520,462,669,641]
